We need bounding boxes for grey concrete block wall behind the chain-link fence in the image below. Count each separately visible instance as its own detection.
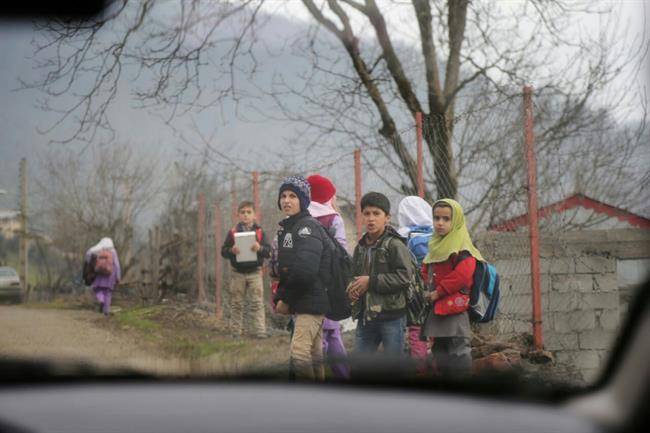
[477,230,650,382]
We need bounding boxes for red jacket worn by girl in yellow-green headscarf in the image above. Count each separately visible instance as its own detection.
[422,254,476,316]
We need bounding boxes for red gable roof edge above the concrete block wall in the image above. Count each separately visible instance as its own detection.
[488,193,650,232]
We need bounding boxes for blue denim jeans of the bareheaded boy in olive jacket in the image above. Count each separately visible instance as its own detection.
[355,317,406,356]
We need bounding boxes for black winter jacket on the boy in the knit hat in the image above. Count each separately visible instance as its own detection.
[275,211,332,314]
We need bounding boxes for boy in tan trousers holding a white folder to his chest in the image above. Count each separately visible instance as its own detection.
[221,201,271,338]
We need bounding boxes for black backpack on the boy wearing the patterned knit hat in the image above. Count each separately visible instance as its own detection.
[318,224,352,320]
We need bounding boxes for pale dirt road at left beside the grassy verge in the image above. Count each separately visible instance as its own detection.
[0,305,187,373]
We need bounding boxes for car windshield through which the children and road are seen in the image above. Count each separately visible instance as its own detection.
[0,0,650,387]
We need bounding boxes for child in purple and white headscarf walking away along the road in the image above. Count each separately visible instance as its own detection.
[86,238,122,316]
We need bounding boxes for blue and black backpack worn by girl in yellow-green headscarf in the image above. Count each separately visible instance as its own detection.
[456,251,501,323]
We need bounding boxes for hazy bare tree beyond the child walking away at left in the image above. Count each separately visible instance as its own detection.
[37,145,161,278]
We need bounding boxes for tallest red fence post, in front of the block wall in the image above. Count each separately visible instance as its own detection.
[524,86,544,350]
